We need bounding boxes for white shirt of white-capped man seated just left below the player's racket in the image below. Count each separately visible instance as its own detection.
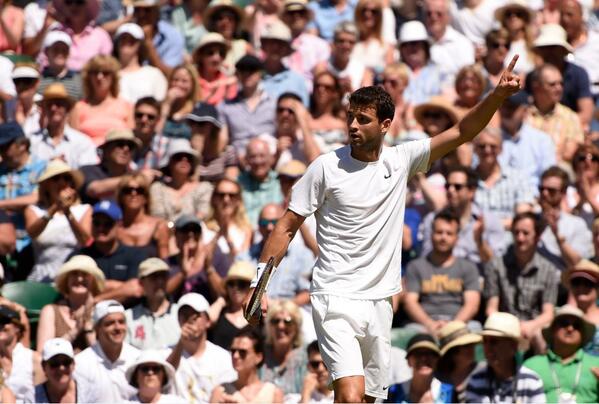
[177,341,237,403]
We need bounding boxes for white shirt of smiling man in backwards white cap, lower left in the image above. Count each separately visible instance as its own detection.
[75,343,140,403]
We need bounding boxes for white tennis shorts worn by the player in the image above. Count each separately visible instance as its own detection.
[310,295,393,398]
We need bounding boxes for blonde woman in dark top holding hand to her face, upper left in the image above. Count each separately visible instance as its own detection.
[156,64,201,140]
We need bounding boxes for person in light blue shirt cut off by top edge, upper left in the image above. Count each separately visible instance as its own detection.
[132,0,184,76]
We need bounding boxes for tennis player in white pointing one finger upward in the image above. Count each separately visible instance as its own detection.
[244,57,520,402]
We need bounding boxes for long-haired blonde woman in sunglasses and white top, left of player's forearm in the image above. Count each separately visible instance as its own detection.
[203,178,252,277]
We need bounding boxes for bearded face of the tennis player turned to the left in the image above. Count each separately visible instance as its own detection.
[347,105,391,150]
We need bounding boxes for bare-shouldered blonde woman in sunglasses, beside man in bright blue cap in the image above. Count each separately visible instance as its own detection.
[116,172,169,259]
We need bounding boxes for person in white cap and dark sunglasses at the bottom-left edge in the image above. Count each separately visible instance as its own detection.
[32,338,103,403]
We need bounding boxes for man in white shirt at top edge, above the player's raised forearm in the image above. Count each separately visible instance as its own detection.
[424,0,474,88]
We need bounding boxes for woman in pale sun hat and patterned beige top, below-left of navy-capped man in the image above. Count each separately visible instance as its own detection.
[150,139,212,223]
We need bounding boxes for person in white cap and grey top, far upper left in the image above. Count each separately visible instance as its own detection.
[38,31,83,101]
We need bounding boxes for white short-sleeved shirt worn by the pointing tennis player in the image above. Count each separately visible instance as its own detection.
[289,139,430,299]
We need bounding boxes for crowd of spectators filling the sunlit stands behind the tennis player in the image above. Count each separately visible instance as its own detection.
[0,0,599,403]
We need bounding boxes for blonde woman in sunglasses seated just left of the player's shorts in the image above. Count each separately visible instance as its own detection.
[260,300,307,395]
